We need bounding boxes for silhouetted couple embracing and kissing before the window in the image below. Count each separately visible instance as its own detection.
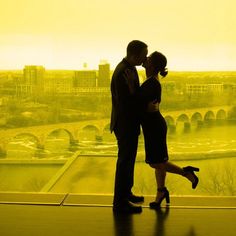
[110,40,199,214]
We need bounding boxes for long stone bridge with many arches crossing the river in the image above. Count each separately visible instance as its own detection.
[0,107,230,153]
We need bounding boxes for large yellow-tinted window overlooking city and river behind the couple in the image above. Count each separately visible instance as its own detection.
[0,0,236,196]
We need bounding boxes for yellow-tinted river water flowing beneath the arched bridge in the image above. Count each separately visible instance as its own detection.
[6,122,236,160]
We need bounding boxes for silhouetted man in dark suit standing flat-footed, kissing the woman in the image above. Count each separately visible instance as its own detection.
[110,40,148,213]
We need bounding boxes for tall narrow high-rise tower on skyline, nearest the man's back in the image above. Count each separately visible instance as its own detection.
[97,61,110,87]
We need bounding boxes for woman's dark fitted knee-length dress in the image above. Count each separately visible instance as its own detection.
[140,77,168,164]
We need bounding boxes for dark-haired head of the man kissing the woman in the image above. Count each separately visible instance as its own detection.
[126,40,148,66]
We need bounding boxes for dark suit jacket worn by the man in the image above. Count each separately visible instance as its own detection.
[110,58,140,137]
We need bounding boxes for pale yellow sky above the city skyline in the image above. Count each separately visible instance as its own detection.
[0,0,236,70]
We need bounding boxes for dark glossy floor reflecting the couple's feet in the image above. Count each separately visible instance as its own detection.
[0,194,236,236]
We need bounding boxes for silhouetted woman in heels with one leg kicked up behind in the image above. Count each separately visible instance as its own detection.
[140,52,199,209]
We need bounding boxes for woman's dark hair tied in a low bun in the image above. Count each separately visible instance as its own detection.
[150,51,168,77]
